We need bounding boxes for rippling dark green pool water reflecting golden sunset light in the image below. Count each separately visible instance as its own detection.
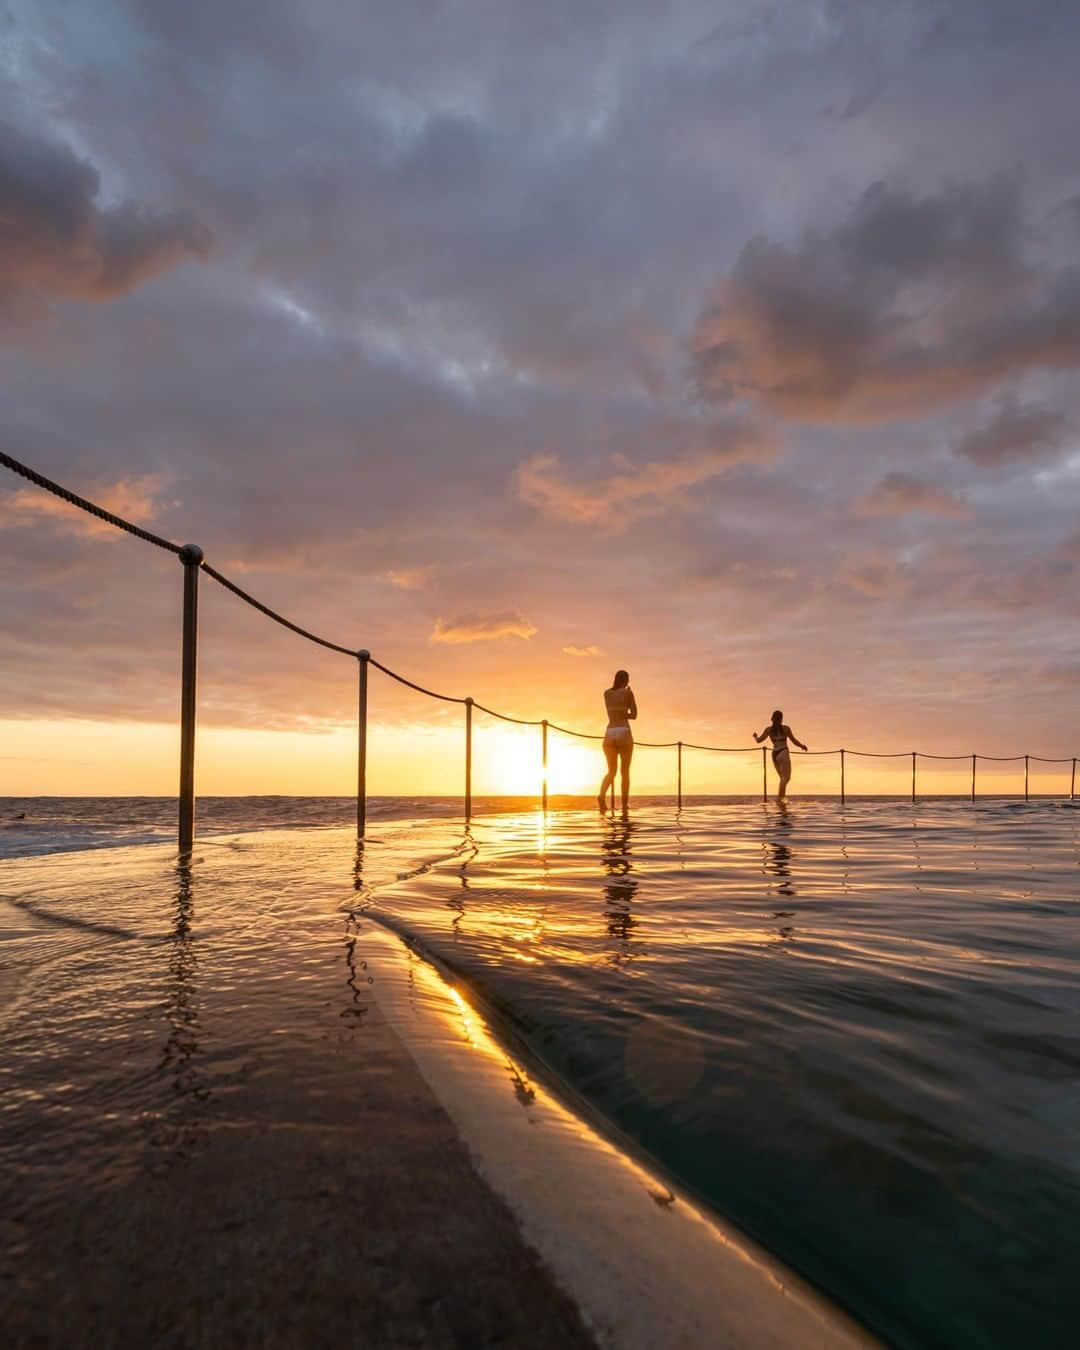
[361,802,1080,1347]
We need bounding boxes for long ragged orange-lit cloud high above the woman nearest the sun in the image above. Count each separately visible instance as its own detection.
[516,420,775,532]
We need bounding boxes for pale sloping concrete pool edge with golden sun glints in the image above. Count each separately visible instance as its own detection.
[360,911,880,1350]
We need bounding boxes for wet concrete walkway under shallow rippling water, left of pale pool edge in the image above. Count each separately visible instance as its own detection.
[0,833,593,1350]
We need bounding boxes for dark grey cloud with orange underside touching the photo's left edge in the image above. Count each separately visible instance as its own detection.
[0,123,211,311]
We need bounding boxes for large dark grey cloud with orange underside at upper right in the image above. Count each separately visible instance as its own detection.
[693,178,1080,423]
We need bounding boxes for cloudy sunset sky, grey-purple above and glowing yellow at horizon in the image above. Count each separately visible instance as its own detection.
[0,0,1080,794]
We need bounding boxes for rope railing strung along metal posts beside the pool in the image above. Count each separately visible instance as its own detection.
[0,451,1077,851]
